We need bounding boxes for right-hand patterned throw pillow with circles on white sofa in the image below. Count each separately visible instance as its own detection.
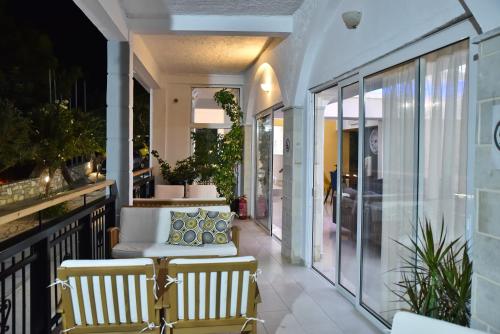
[201,210,234,244]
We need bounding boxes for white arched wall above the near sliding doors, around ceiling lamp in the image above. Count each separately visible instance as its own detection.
[247,0,470,106]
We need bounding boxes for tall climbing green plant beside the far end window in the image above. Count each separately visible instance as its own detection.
[213,89,244,204]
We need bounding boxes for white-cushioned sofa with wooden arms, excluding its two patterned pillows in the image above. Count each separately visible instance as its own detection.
[109,205,239,258]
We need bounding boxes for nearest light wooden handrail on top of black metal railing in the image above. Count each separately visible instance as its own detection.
[0,180,115,225]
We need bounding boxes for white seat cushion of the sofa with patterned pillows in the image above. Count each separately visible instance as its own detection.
[112,241,238,259]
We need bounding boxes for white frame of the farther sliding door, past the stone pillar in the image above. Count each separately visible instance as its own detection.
[253,102,284,236]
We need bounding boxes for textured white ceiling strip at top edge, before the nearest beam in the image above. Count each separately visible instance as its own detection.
[121,0,304,18]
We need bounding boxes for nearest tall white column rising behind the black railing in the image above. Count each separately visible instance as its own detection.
[106,41,133,210]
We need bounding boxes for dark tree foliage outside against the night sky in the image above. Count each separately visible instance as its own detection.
[0,0,105,191]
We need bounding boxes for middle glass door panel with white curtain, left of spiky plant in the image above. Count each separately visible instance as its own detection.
[361,61,418,321]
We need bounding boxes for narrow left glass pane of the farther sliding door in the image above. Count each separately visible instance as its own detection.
[255,113,273,231]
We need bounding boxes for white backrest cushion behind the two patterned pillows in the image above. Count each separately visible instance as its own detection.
[120,205,231,243]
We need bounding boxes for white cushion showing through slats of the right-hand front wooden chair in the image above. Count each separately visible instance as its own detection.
[170,256,255,320]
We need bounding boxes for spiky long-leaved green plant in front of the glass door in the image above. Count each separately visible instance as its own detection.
[393,221,472,326]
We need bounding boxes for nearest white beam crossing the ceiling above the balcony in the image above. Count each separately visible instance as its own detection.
[126,15,293,37]
